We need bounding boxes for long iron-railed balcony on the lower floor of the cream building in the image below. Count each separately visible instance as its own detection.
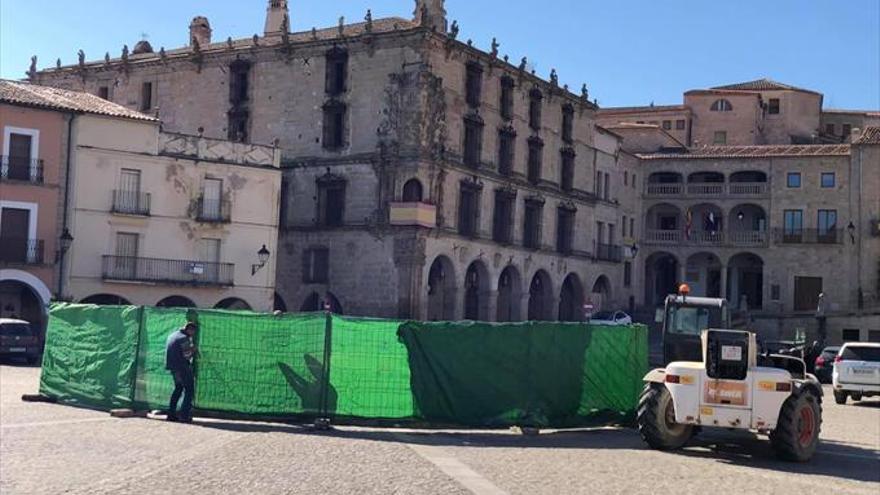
[102,256,235,287]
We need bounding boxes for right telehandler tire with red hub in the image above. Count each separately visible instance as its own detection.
[770,390,822,462]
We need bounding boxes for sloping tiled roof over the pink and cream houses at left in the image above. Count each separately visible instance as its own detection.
[0,79,158,122]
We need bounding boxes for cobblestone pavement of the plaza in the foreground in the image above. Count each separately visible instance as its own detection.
[0,365,880,495]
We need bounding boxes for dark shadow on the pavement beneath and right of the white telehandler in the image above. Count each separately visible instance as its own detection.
[670,432,880,482]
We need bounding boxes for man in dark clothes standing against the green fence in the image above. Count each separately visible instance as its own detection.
[165,322,198,423]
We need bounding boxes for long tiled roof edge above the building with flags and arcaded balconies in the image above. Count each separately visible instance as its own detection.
[638,144,850,160]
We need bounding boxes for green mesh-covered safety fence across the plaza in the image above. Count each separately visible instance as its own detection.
[40,304,648,427]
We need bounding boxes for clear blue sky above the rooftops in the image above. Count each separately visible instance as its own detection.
[0,0,880,110]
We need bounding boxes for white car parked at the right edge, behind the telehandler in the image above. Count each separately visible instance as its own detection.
[831,342,880,404]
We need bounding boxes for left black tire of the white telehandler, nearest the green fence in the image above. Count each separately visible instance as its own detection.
[637,382,694,450]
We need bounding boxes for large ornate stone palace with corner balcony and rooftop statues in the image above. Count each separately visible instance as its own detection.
[25,0,641,320]
